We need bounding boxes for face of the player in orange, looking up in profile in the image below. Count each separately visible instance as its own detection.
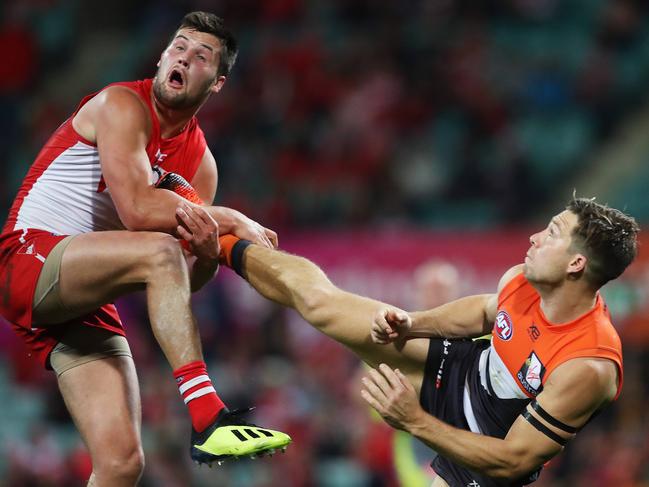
[523,210,585,284]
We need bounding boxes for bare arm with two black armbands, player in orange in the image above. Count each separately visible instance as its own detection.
[362,358,617,480]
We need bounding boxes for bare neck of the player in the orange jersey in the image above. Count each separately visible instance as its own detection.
[539,281,597,325]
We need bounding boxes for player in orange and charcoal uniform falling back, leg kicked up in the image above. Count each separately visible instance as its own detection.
[200,198,639,487]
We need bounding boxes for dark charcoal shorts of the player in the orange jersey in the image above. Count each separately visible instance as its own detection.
[420,339,525,487]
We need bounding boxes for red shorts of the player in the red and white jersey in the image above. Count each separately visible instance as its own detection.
[0,229,125,369]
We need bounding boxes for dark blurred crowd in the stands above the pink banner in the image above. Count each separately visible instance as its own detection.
[0,0,649,227]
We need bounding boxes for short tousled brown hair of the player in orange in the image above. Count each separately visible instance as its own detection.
[566,197,640,289]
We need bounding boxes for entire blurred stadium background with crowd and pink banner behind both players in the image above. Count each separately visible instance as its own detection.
[0,0,649,487]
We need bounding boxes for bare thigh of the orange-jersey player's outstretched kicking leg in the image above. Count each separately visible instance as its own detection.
[313,289,429,390]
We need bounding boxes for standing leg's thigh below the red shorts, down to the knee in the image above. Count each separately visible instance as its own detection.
[58,356,142,468]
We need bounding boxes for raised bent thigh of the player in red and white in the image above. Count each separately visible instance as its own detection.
[59,231,184,311]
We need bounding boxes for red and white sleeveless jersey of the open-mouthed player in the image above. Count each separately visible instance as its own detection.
[2,79,206,235]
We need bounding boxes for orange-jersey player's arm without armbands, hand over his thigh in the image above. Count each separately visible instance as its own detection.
[372,265,523,344]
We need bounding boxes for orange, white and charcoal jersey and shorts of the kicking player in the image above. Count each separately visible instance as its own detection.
[420,274,622,487]
